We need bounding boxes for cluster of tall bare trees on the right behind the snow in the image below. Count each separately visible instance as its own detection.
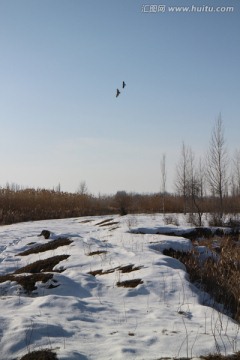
[175,115,240,225]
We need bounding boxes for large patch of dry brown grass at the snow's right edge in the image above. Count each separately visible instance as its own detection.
[163,237,240,322]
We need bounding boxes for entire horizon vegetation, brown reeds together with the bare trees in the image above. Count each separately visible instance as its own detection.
[0,115,240,226]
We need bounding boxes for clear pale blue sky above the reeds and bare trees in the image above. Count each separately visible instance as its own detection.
[0,0,240,194]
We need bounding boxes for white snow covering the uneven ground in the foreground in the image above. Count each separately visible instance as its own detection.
[0,215,240,360]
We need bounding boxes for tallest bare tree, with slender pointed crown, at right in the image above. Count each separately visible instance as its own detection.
[207,115,228,218]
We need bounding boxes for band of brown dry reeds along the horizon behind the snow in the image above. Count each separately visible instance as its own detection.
[0,187,240,225]
